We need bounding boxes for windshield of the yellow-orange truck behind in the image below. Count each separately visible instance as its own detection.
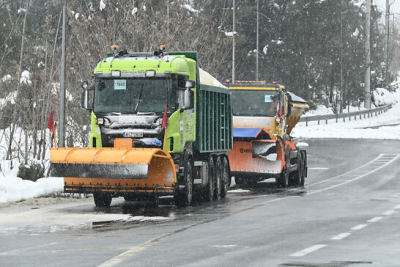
[231,90,279,117]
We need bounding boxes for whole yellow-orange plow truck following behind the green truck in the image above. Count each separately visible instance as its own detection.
[227,81,308,188]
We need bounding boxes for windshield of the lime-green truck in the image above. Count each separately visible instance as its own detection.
[94,77,175,113]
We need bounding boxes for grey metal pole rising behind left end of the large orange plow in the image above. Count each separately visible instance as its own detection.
[58,0,67,147]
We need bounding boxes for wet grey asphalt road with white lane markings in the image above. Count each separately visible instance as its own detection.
[0,139,400,267]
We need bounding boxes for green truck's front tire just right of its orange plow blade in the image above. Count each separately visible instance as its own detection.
[175,155,193,207]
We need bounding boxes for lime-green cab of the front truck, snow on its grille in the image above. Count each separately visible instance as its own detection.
[82,52,197,153]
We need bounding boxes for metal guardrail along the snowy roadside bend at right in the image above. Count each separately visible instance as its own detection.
[300,104,392,126]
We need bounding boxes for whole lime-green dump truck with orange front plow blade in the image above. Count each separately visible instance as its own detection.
[50,46,233,206]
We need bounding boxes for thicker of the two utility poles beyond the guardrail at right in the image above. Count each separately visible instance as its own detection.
[364,0,371,109]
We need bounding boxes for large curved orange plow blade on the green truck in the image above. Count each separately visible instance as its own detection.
[50,147,176,193]
